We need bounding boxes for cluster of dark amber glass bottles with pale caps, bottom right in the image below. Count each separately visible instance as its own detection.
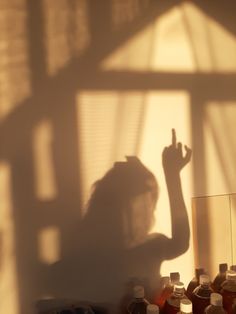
[127,264,236,314]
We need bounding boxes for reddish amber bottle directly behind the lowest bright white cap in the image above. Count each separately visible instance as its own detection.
[164,282,187,314]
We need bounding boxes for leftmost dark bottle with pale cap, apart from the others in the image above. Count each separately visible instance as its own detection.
[127,286,149,314]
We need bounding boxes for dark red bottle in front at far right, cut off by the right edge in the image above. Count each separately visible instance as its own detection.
[220,270,236,314]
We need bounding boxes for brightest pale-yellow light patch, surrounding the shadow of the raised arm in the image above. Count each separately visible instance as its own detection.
[139,91,193,284]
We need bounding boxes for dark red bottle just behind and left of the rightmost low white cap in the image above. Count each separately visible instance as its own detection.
[192,274,213,314]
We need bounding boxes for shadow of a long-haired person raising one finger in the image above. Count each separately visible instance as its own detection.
[48,130,191,313]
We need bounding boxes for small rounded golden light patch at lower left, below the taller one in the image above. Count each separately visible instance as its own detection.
[38,227,60,264]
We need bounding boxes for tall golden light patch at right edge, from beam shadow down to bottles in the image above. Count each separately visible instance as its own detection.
[193,101,236,276]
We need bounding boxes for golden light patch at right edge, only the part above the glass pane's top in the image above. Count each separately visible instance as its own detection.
[204,101,236,195]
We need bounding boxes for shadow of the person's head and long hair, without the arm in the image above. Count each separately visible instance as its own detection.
[77,156,158,250]
